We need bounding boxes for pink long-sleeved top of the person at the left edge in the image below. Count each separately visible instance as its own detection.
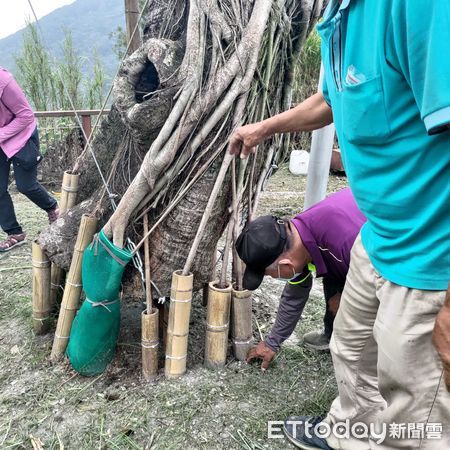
[0,67,36,158]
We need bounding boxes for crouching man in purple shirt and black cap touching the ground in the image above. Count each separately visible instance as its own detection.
[236,188,366,370]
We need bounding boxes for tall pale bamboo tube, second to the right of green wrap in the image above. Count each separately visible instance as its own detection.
[165,270,194,378]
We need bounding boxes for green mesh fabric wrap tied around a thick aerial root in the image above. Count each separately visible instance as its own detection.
[67,231,132,376]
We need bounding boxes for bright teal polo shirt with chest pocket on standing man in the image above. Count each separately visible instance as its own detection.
[317,0,450,290]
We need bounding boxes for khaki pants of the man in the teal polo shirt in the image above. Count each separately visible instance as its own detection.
[325,236,450,450]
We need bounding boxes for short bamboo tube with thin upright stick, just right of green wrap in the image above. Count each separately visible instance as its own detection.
[141,214,159,381]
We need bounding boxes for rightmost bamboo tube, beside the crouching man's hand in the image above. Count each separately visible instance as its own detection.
[231,286,253,361]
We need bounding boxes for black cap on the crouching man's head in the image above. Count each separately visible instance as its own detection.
[236,216,287,291]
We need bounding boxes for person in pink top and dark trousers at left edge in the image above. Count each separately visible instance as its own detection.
[0,67,59,252]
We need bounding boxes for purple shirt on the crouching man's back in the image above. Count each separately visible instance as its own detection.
[292,188,366,283]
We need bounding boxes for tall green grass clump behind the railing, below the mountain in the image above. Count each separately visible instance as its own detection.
[15,23,105,111]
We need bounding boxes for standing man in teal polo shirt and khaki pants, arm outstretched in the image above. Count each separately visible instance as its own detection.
[230,0,450,449]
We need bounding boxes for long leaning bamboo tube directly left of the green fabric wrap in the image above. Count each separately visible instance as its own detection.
[51,214,97,361]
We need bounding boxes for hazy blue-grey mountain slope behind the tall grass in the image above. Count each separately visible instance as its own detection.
[0,0,125,82]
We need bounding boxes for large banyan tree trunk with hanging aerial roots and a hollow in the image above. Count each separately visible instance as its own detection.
[39,0,326,295]
